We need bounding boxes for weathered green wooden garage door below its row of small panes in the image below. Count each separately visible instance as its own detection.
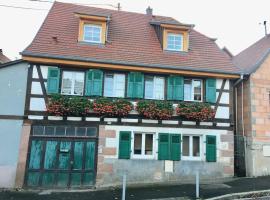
[26,138,96,188]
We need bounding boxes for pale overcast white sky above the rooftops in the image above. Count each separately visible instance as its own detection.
[0,0,270,60]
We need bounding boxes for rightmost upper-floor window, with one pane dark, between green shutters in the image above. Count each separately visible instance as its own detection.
[184,79,202,101]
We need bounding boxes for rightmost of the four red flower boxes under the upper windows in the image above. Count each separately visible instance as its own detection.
[176,102,215,121]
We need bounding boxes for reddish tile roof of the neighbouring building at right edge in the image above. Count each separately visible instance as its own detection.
[233,35,270,74]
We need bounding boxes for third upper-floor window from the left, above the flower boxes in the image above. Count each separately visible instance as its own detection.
[145,76,165,100]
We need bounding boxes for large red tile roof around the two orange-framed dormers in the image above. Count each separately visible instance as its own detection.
[22,2,239,74]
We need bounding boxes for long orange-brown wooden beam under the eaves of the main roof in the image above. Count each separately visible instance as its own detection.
[22,56,240,79]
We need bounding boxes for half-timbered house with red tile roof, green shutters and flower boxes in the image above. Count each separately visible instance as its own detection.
[1,2,241,188]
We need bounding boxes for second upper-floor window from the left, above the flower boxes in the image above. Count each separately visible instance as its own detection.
[104,74,126,97]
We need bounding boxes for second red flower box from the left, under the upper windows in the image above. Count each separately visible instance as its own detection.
[93,98,133,117]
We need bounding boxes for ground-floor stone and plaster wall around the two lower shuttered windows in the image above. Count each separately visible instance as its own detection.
[96,125,234,187]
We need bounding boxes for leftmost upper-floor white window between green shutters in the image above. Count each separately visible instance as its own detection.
[61,71,84,96]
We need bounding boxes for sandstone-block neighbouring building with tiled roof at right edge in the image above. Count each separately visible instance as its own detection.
[233,35,270,176]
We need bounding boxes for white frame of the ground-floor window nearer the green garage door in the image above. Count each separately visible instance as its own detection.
[131,131,157,160]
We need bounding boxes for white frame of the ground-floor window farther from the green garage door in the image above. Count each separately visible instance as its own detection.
[181,134,204,161]
